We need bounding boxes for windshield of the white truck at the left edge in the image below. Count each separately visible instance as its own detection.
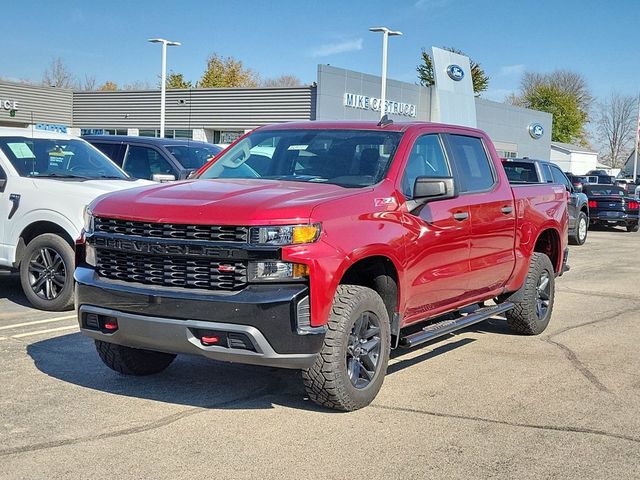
[0,137,129,180]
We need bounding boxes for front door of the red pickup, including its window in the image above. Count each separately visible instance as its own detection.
[401,133,471,324]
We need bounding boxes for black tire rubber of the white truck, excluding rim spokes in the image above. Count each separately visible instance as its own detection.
[20,233,75,312]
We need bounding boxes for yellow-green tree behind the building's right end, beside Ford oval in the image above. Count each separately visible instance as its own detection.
[507,70,593,146]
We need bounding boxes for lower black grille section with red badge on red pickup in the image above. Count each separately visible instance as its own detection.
[96,249,247,290]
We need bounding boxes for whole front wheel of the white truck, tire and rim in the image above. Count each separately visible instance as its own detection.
[20,233,75,311]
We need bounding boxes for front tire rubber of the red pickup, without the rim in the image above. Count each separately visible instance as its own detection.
[302,285,391,411]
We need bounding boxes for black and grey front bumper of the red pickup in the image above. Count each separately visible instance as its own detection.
[75,267,325,369]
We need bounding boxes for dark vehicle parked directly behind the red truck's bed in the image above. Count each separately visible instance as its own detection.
[502,158,589,245]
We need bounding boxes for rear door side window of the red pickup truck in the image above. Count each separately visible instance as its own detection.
[449,135,495,192]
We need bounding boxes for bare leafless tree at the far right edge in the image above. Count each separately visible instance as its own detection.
[596,92,637,168]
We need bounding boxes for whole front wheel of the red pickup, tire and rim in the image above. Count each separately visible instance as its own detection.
[302,285,391,411]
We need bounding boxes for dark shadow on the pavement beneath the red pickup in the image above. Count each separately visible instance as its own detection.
[27,326,480,413]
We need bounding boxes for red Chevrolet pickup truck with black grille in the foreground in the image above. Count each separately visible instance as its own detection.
[75,121,567,410]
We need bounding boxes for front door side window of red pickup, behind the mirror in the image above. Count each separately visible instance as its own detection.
[402,134,451,198]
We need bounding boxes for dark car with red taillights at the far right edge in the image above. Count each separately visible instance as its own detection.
[583,185,638,232]
